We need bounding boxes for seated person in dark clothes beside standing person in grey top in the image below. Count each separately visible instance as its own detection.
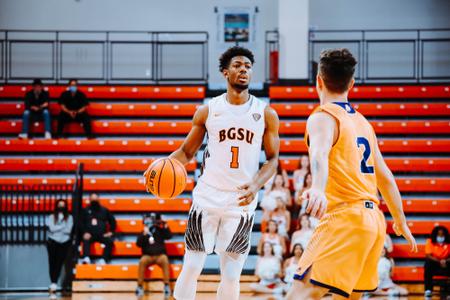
[80,194,116,265]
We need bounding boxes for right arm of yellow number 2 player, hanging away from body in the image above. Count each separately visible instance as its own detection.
[374,145,417,252]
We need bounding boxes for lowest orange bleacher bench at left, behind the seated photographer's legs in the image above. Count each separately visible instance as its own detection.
[75,264,181,280]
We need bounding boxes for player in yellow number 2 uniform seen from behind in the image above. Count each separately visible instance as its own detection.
[287,49,417,300]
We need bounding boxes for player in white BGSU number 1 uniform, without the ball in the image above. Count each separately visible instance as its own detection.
[170,46,279,300]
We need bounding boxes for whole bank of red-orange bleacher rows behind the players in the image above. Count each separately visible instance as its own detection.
[0,86,450,282]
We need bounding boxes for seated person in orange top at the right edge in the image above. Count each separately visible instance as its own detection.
[424,226,450,297]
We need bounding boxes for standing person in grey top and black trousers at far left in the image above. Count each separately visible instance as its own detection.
[45,199,73,294]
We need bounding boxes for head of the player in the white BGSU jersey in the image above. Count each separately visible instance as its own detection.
[219,46,255,92]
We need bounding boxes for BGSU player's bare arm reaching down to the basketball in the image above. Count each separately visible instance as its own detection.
[169,105,208,165]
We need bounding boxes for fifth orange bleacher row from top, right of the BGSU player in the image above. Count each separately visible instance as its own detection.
[280,157,450,172]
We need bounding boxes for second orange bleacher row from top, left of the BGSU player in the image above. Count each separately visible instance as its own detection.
[0,102,199,117]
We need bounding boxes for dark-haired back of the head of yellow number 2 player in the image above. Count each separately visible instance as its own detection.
[319,48,358,94]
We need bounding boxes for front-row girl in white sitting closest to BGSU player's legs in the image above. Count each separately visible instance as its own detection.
[250,242,284,294]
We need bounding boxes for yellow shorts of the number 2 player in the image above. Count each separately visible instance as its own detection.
[294,201,386,297]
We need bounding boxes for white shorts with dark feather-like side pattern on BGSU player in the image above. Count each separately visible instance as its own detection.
[185,179,257,255]
